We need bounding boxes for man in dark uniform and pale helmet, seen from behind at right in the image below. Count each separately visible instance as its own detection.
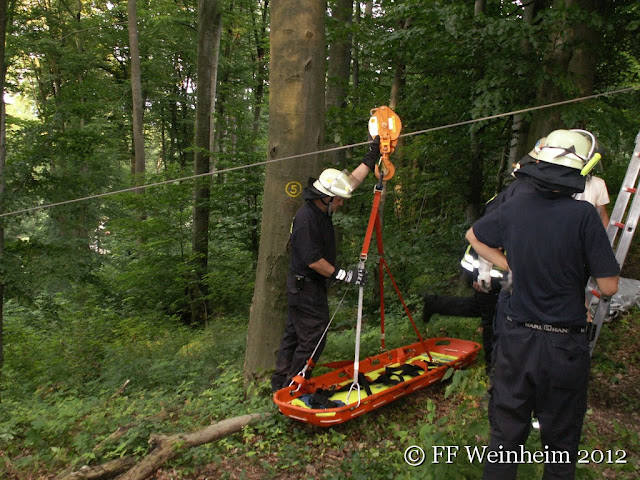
[466,130,620,480]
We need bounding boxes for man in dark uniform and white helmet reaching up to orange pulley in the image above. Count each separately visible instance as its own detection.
[271,137,380,391]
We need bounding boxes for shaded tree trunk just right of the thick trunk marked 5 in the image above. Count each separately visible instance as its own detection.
[325,0,353,169]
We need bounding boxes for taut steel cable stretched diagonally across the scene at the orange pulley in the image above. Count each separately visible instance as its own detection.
[0,85,640,218]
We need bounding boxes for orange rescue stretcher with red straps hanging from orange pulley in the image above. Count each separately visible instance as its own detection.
[273,107,480,427]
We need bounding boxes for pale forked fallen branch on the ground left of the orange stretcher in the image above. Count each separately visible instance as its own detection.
[118,413,272,480]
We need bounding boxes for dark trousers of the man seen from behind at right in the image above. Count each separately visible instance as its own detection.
[483,316,590,480]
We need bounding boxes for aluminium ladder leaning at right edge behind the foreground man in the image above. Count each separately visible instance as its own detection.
[586,132,640,355]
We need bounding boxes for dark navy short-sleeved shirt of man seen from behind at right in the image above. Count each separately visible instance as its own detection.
[488,192,615,325]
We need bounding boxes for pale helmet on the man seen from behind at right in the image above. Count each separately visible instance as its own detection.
[529,129,601,175]
